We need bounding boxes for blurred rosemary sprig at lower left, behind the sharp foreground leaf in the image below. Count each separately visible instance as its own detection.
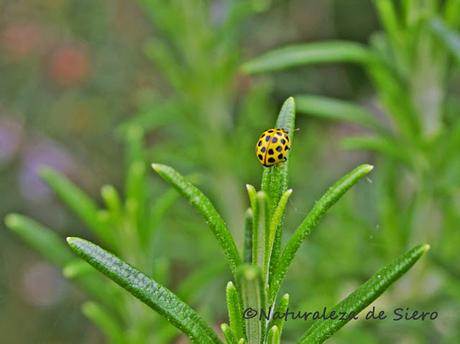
[5,127,222,344]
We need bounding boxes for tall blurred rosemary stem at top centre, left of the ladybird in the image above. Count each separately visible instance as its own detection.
[120,0,270,236]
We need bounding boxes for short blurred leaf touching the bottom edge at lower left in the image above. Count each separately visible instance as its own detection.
[82,302,125,344]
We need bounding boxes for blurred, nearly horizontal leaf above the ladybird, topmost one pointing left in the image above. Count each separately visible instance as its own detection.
[242,41,372,74]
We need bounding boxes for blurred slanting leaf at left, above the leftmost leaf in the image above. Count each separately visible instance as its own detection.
[40,167,114,245]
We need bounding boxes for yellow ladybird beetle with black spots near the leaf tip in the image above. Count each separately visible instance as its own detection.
[256,128,291,167]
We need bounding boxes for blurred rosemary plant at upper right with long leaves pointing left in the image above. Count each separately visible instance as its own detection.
[245,0,460,248]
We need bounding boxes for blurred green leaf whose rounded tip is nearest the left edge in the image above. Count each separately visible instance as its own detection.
[5,214,75,268]
